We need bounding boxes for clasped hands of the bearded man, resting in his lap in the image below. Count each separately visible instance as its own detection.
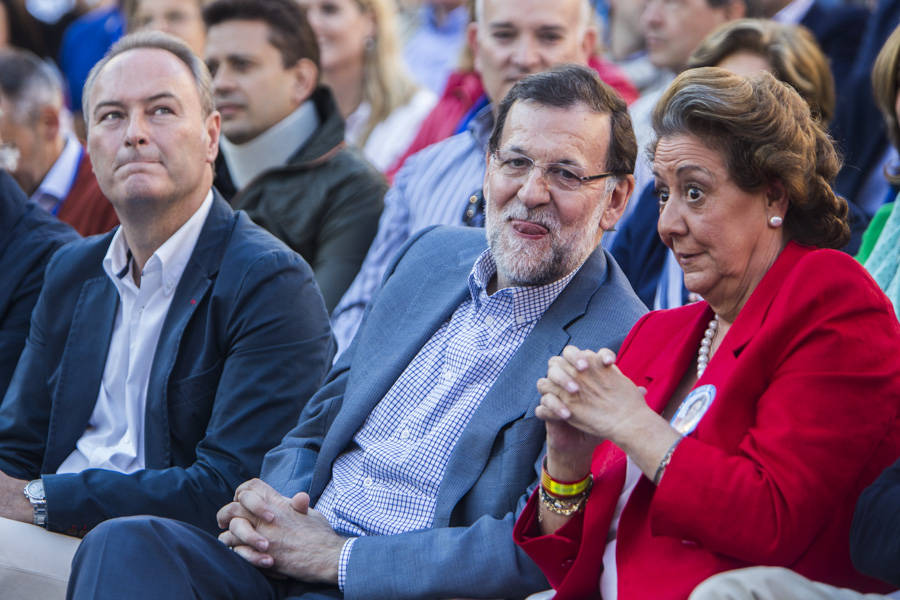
[216,479,347,585]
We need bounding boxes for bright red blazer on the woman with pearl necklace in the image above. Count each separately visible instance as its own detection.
[514,243,900,600]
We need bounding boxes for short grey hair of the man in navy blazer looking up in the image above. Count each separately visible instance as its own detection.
[82,31,215,127]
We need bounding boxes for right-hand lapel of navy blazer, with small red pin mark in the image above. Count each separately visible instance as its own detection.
[144,195,237,469]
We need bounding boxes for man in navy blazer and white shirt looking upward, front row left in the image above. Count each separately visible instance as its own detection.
[0,32,333,599]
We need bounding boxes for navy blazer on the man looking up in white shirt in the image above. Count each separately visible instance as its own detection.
[0,193,334,533]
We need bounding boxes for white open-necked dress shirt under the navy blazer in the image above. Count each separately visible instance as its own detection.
[56,190,212,473]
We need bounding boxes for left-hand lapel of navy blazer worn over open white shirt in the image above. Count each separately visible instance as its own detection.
[41,274,119,473]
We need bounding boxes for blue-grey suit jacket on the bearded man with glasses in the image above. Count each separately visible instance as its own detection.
[262,227,646,599]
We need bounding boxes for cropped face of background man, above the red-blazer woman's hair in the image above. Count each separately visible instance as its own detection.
[641,0,744,72]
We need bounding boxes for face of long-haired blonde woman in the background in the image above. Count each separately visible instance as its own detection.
[297,0,375,71]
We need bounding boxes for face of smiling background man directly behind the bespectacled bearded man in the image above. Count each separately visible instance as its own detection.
[469,0,596,103]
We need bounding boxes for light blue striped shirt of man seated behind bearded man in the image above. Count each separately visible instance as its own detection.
[331,106,494,358]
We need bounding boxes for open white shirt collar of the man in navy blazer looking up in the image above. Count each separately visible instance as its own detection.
[103,190,213,296]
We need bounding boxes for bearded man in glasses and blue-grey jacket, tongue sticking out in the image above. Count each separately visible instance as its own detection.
[70,66,643,598]
